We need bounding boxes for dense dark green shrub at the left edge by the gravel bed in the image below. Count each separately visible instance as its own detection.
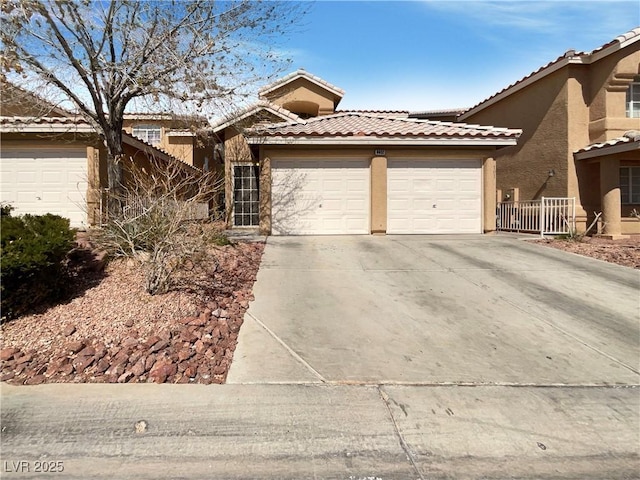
[0,207,75,319]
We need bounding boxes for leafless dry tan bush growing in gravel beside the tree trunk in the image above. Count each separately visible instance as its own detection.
[92,159,223,295]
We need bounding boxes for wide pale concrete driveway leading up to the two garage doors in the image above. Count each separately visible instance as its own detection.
[228,236,640,386]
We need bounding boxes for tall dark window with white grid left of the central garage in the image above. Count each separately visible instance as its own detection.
[233,165,260,227]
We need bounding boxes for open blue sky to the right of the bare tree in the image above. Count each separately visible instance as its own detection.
[284,0,640,111]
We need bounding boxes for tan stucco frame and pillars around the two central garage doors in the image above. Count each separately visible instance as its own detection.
[255,145,496,234]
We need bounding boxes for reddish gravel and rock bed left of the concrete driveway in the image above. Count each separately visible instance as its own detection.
[0,242,264,385]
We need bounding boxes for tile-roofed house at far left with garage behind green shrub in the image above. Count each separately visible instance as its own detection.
[0,83,199,229]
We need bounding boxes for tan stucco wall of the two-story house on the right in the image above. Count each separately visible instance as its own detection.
[464,43,640,230]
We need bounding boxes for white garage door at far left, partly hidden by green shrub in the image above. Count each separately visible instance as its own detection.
[0,147,87,227]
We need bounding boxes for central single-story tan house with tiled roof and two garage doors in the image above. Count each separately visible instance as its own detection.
[213,70,520,234]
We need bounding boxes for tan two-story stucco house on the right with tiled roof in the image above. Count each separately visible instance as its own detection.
[458,28,640,237]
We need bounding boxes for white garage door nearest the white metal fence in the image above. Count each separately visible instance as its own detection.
[387,159,482,234]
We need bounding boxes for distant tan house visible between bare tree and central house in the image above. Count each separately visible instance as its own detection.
[122,113,215,170]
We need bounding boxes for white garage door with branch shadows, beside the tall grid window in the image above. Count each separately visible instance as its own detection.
[271,159,370,235]
